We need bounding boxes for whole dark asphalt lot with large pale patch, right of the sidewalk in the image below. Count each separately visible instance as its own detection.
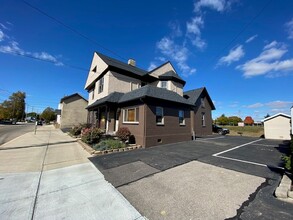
[91,136,293,219]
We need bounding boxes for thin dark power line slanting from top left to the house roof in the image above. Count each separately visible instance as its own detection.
[22,0,127,60]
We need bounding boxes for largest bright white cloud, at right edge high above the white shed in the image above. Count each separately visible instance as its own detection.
[236,41,293,78]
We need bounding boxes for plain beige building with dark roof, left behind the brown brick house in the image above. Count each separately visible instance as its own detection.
[57,93,88,129]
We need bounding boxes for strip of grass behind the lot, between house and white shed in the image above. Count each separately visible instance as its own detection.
[222,126,264,137]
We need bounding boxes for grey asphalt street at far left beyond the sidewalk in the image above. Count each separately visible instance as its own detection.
[0,124,35,146]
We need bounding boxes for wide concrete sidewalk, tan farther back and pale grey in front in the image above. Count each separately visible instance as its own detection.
[0,126,144,220]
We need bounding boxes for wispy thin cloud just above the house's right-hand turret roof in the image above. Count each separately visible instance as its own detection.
[157,37,196,76]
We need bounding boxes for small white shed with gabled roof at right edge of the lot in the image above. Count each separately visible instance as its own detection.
[263,113,291,140]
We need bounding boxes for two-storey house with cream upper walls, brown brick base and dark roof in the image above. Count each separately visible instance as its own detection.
[85,53,215,147]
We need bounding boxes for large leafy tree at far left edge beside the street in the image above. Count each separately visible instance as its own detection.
[0,91,26,120]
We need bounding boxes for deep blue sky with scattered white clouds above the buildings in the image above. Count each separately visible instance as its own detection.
[0,0,293,120]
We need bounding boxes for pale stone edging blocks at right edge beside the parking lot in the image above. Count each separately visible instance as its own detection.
[275,174,293,202]
